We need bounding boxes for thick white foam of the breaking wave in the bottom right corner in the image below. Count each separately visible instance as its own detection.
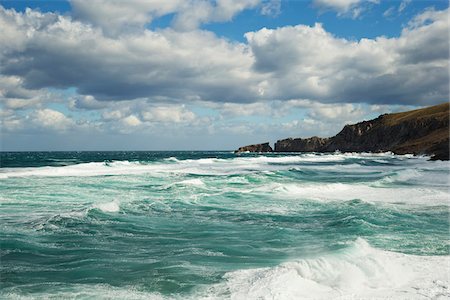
[209,238,450,299]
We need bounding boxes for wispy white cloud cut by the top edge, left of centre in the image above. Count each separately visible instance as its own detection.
[71,0,260,36]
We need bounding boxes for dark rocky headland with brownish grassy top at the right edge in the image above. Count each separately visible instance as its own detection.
[241,103,449,160]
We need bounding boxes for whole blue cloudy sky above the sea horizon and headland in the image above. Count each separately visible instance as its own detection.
[0,0,449,151]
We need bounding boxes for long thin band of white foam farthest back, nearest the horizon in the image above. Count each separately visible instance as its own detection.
[0,153,442,179]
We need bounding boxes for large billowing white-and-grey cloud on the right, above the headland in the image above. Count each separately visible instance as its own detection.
[246,10,449,105]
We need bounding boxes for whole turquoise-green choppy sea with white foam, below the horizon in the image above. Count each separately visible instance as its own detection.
[0,151,450,299]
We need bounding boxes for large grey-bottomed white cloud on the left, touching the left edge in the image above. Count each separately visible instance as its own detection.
[0,8,258,101]
